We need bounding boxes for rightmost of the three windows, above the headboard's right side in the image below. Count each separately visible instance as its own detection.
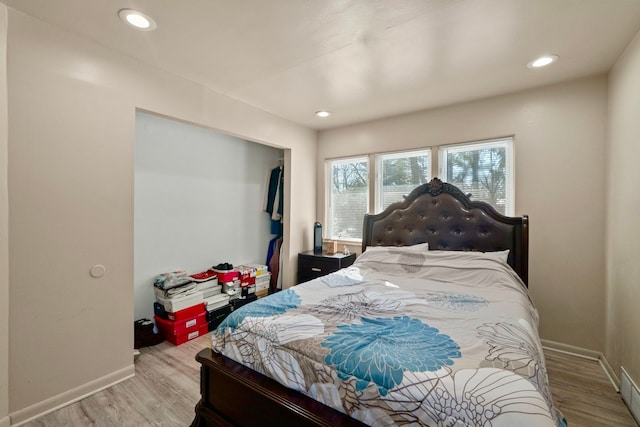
[439,138,514,215]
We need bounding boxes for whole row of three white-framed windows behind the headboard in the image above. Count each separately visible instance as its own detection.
[325,138,515,240]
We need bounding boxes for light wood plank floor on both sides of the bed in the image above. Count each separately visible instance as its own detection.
[25,334,636,427]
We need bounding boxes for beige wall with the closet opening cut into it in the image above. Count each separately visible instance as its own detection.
[5,9,316,423]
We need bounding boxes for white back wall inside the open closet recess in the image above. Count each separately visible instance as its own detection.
[133,112,284,319]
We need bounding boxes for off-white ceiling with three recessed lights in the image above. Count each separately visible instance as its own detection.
[0,0,640,129]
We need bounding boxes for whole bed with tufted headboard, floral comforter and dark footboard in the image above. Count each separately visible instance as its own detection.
[192,178,566,427]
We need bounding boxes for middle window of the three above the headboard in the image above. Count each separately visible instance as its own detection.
[375,150,431,212]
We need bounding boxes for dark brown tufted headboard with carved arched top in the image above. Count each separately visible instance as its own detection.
[362,178,529,285]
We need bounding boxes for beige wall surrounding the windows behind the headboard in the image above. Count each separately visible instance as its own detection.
[317,76,607,351]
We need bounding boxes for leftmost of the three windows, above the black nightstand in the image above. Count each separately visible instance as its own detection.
[325,157,369,239]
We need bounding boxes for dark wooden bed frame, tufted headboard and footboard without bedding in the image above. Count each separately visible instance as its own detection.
[191,178,529,427]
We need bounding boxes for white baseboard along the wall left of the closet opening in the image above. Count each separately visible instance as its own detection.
[9,365,135,427]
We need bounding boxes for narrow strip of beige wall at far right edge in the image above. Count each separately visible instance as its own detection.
[605,28,640,384]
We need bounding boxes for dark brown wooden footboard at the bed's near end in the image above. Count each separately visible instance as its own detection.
[191,348,364,427]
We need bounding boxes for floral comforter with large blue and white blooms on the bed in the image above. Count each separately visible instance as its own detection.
[212,247,566,427]
